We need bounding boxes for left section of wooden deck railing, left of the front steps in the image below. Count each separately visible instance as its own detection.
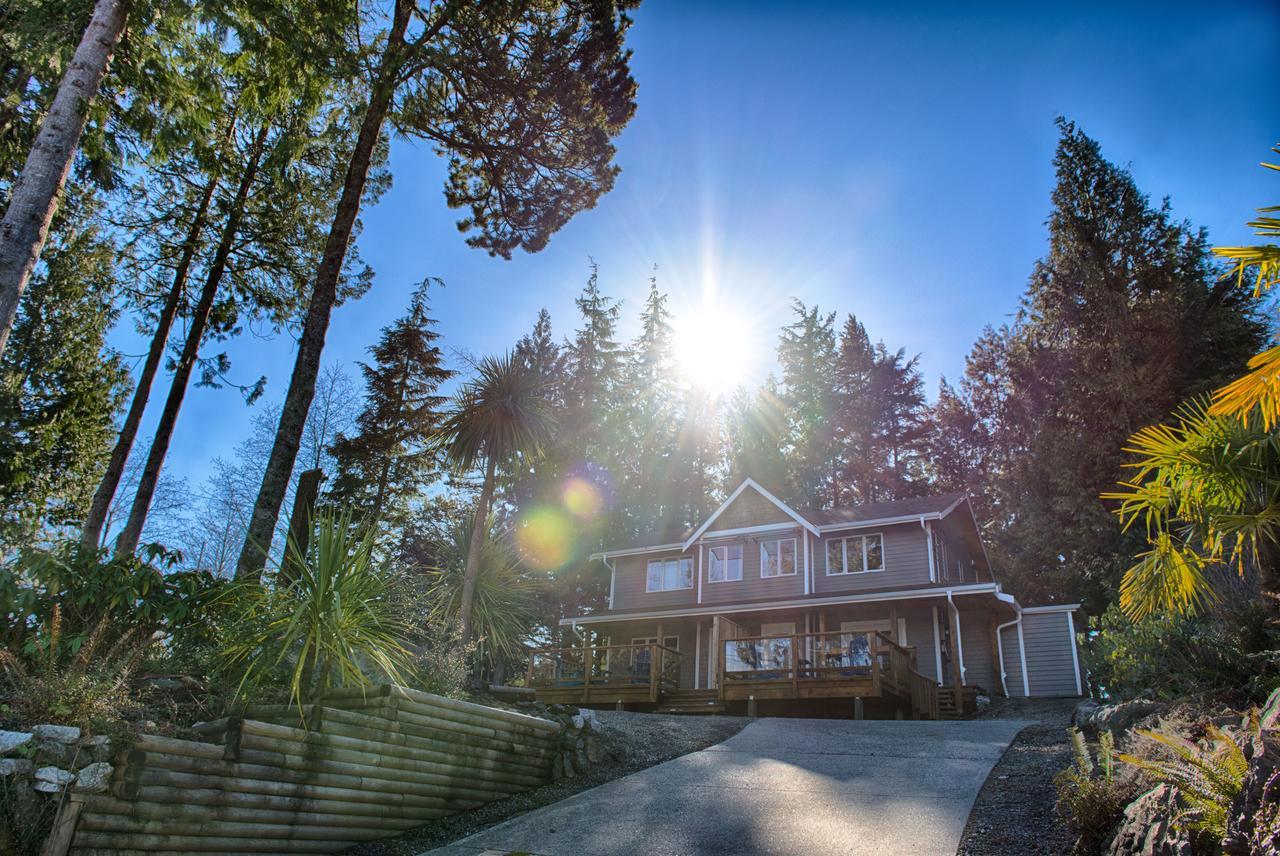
[526,645,684,701]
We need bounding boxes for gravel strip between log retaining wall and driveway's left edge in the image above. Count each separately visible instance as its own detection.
[344,710,750,856]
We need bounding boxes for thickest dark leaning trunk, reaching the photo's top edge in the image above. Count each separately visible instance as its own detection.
[236,0,414,578]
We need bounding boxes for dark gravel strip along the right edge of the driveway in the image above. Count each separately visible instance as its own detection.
[956,699,1076,856]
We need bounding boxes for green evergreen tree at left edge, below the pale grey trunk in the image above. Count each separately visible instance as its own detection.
[0,200,127,546]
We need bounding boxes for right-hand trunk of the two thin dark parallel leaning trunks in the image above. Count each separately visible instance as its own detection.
[115,122,270,555]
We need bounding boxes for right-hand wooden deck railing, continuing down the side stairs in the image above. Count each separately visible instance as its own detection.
[718,631,938,719]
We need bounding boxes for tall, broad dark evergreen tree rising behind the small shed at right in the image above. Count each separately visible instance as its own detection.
[933,120,1265,605]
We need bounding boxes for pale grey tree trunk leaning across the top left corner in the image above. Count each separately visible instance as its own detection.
[0,0,129,354]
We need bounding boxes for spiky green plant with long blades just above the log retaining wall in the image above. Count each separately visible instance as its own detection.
[224,511,412,706]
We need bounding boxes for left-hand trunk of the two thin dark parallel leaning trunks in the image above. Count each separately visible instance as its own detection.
[81,178,218,550]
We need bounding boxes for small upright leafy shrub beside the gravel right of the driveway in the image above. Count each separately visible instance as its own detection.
[1053,728,1137,853]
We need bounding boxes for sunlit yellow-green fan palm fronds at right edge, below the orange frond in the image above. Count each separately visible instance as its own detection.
[1103,400,1280,618]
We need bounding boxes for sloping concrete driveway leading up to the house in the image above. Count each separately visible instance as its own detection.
[431,719,1029,856]
